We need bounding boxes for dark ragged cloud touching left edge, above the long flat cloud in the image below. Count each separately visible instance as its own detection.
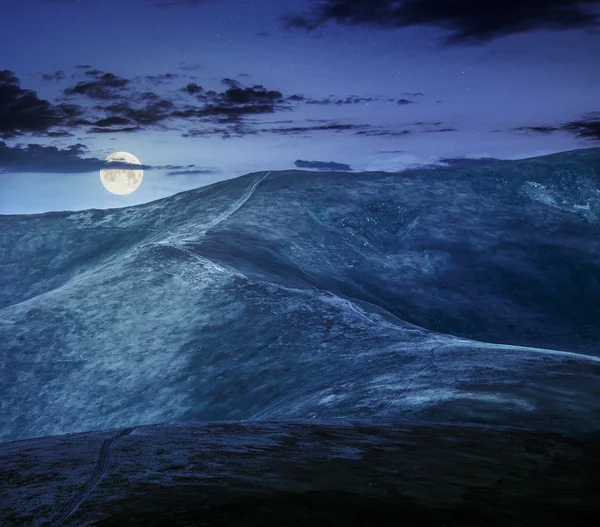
[0,70,78,138]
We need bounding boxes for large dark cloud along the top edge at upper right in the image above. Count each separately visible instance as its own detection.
[283,0,600,44]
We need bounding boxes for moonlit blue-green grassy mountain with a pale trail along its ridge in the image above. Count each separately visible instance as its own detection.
[0,145,600,441]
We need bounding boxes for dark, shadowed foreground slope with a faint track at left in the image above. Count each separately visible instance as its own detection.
[0,421,600,527]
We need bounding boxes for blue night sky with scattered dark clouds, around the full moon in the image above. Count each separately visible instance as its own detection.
[0,0,600,214]
